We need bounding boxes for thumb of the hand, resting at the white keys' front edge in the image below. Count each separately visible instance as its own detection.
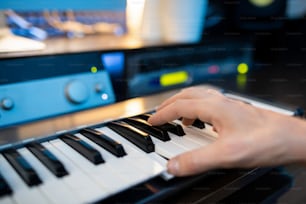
[167,138,251,176]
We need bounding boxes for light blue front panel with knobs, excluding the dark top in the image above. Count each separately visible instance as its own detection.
[0,71,115,127]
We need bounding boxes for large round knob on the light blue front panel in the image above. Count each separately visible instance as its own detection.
[65,80,89,104]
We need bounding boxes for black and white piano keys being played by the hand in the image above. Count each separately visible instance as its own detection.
[0,93,302,204]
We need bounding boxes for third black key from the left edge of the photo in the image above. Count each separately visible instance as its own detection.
[26,142,68,177]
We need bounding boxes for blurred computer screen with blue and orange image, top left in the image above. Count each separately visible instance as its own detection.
[0,0,126,52]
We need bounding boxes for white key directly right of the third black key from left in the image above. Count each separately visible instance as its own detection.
[42,142,105,203]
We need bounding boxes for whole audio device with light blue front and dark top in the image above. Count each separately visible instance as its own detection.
[0,52,116,127]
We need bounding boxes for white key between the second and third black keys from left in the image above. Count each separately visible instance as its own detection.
[18,148,80,203]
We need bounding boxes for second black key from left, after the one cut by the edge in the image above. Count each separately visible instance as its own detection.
[3,149,42,186]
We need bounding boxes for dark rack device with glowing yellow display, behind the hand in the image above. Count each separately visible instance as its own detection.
[126,40,253,97]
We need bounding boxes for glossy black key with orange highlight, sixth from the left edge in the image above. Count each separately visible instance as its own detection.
[107,121,155,153]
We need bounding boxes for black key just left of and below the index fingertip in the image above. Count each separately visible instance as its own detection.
[123,118,170,141]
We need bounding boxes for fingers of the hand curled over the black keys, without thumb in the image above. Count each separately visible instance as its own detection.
[148,88,226,125]
